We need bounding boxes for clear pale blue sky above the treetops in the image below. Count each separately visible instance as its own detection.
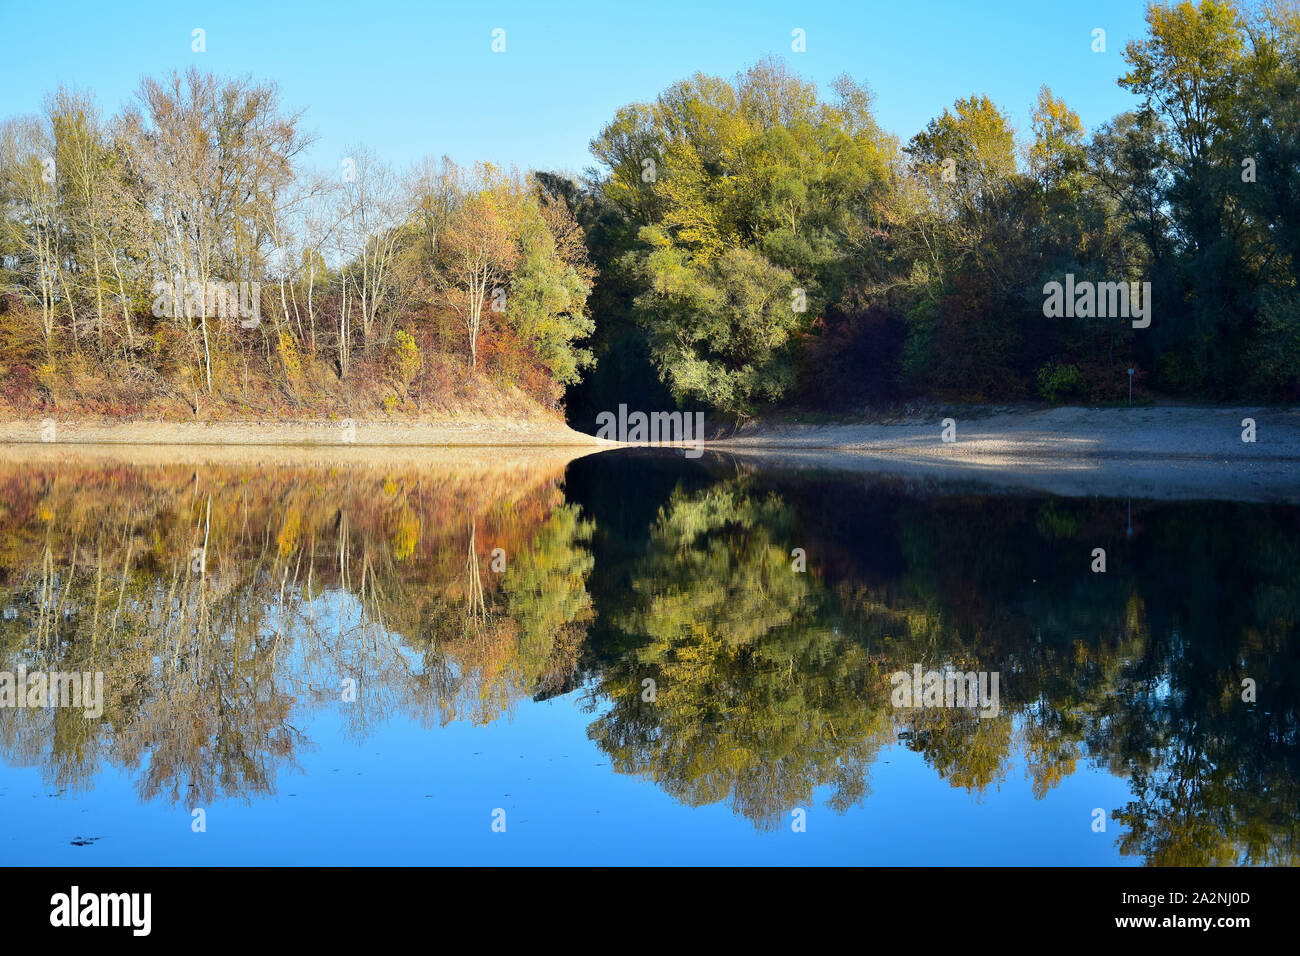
[0,0,1145,178]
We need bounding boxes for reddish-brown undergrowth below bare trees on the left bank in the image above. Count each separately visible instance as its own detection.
[0,300,563,423]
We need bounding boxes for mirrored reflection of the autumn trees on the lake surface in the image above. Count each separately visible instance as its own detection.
[0,455,1300,865]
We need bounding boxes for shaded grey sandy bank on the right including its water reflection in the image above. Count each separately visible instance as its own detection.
[710,406,1300,502]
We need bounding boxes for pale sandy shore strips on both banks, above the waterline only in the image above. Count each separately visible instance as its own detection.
[0,406,1300,455]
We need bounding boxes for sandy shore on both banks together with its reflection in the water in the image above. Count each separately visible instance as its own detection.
[0,406,1300,501]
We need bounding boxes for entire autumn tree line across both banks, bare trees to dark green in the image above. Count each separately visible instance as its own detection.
[0,0,1300,425]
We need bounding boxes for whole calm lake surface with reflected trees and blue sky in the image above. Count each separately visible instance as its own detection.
[0,450,1300,865]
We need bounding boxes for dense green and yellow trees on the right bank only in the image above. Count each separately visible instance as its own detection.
[569,0,1300,415]
